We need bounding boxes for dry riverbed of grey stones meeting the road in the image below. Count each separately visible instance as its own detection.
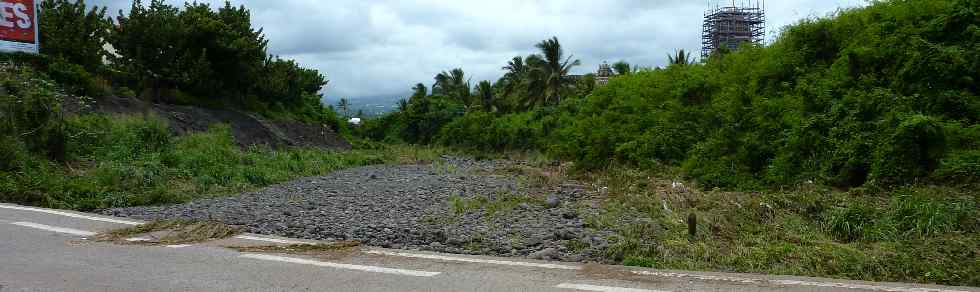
[103,157,609,261]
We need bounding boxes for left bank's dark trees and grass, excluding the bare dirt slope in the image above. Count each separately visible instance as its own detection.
[0,0,378,210]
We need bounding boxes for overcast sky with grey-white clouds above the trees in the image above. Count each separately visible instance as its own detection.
[87,0,866,100]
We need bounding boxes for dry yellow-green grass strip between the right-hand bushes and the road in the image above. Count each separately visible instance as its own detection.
[586,167,980,286]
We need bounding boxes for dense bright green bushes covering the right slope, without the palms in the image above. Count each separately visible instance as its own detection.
[560,0,980,187]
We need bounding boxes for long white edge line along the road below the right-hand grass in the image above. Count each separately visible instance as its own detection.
[633,271,968,292]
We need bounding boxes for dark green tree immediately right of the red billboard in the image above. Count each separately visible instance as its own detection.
[40,0,112,72]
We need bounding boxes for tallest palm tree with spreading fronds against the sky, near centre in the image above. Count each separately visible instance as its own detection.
[528,37,582,103]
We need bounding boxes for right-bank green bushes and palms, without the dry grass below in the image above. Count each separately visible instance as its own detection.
[364,0,980,189]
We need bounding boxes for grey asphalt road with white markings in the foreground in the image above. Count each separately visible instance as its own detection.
[0,204,980,292]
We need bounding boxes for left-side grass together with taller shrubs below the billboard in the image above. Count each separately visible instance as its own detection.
[0,66,396,210]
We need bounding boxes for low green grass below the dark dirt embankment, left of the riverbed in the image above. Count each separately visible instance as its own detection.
[0,115,443,211]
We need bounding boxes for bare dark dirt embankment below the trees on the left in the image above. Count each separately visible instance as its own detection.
[65,97,351,150]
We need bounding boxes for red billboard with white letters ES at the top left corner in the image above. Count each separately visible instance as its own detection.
[0,0,40,54]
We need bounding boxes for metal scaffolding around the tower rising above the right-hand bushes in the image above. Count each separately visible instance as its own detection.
[701,1,766,59]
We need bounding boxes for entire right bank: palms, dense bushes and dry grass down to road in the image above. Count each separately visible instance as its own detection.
[358,0,980,286]
